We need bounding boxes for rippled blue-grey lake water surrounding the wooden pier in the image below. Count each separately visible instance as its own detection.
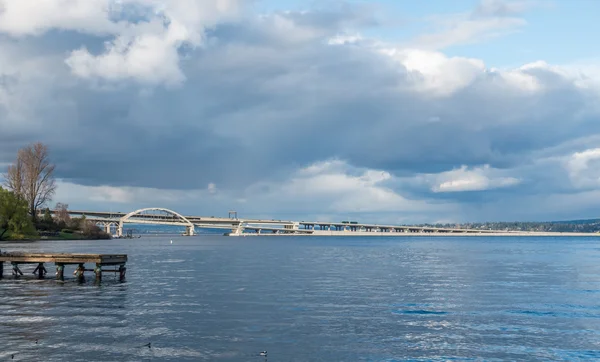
[0,236,600,362]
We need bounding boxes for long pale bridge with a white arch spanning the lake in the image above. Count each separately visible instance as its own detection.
[44,207,536,237]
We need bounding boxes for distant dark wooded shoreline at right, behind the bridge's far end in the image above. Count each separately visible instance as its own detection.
[423,220,600,233]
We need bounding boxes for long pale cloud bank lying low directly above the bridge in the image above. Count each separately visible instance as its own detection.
[54,160,455,223]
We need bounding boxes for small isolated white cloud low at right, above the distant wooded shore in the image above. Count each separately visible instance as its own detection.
[424,165,521,192]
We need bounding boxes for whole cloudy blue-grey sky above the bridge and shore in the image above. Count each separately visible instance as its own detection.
[0,0,600,224]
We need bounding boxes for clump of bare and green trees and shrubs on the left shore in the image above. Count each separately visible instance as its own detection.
[0,143,110,240]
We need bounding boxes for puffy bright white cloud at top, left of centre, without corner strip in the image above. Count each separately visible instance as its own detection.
[66,0,239,85]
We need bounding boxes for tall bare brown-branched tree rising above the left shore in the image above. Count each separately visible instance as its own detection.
[5,142,56,221]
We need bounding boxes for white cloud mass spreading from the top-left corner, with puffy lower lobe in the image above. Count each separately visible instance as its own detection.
[0,0,241,85]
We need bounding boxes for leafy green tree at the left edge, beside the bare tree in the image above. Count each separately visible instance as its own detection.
[0,187,34,240]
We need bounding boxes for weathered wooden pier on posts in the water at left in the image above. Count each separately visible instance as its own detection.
[0,252,127,281]
